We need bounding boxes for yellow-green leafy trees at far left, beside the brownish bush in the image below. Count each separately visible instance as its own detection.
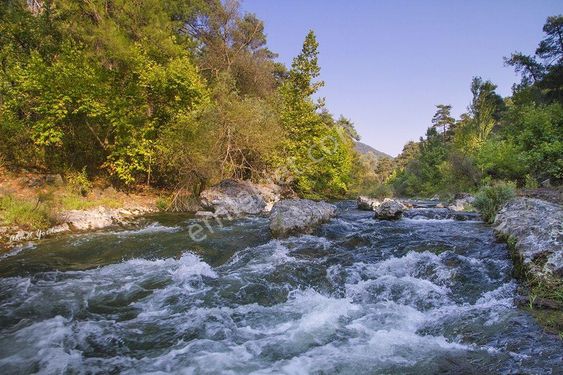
[0,1,207,184]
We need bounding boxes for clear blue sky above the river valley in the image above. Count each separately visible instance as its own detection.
[242,0,563,156]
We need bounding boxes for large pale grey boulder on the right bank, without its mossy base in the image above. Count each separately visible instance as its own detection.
[494,197,563,277]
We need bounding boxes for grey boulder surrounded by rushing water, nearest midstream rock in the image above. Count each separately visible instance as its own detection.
[270,199,336,237]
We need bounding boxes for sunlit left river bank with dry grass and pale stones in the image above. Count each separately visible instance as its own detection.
[0,171,162,250]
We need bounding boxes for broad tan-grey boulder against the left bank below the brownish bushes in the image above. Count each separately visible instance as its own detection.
[200,180,281,217]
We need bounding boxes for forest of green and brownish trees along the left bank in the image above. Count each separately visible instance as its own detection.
[0,0,364,197]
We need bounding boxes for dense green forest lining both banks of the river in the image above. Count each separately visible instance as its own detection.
[0,0,563,203]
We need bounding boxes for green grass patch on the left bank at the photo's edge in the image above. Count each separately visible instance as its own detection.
[0,195,54,229]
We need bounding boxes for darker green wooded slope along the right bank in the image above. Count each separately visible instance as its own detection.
[382,16,563,200]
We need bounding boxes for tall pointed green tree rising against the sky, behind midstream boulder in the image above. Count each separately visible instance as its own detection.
[278,31,352,197]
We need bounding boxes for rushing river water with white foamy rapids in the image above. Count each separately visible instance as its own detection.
[0,202,563,375]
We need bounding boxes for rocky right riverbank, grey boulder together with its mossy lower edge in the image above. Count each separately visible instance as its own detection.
[493,197,563,333]
